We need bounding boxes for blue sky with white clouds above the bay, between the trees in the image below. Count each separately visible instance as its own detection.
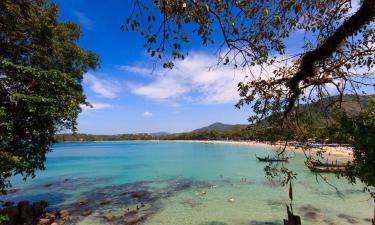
[57,0,370,134]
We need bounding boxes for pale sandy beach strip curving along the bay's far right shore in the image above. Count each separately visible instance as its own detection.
[170,140,353,160]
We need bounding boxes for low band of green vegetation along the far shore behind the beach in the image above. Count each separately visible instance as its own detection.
[55,95,367,143]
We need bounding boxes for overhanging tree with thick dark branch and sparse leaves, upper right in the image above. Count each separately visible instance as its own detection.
[125,0,375,193]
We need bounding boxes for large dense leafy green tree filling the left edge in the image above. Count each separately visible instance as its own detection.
[0,0,98,191]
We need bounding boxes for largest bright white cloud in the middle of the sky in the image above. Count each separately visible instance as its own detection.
[121,52,262,104]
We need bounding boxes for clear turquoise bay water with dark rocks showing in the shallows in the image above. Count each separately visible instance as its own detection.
[0,141,373,225]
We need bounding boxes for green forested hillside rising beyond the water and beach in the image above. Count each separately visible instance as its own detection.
[56,95,374,142]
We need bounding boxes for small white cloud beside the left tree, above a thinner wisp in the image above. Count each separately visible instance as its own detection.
[84,73,118,98]
